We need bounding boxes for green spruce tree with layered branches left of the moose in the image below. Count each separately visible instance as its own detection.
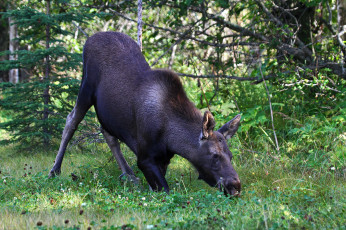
[0,0,95,146]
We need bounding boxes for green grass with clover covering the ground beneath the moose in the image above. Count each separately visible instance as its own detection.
[0,144,346,229]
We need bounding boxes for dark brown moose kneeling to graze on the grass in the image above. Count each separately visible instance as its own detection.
[49,32,241,196]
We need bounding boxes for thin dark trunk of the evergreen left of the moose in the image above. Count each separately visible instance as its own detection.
[43,0,50,144]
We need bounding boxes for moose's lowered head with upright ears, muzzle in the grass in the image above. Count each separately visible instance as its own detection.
[192,111,241,196]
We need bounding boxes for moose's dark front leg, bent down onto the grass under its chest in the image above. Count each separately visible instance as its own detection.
[137,158,169,193]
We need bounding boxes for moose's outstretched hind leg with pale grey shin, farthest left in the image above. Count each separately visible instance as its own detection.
[49,102,90,177]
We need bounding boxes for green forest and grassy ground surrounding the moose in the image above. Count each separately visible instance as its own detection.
[0,0,346,229]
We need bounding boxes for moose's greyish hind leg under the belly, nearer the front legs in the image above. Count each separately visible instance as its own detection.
[101,128,139,184]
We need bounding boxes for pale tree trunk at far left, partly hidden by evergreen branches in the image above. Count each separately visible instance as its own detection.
[8,6,19,84]
